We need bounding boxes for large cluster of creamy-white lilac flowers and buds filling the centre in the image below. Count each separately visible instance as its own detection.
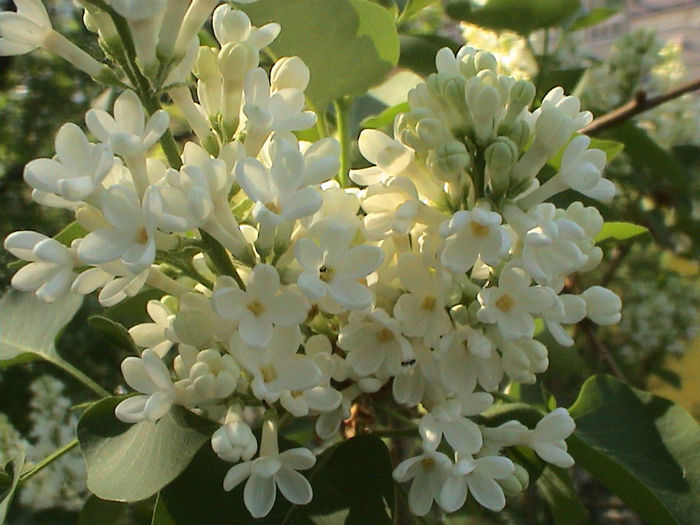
[0,0,620,517]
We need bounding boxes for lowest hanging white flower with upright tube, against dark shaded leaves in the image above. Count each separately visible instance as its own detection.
[224,420,316,518]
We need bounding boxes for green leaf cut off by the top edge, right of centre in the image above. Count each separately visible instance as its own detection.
[445,0,581,35]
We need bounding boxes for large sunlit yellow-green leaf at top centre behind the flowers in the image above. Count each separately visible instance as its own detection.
[238,0,399,114]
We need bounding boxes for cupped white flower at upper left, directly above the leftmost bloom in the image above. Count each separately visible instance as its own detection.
[24,124,114,202]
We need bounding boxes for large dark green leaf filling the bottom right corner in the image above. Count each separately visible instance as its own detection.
[568,376,700,525]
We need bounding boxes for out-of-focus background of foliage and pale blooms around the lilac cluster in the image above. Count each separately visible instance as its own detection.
[0,0,700,525]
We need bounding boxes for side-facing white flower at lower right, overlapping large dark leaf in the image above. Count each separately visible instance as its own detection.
[521,407,576,468]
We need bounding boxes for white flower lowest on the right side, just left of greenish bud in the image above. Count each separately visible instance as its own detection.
[439,456,515,512]
